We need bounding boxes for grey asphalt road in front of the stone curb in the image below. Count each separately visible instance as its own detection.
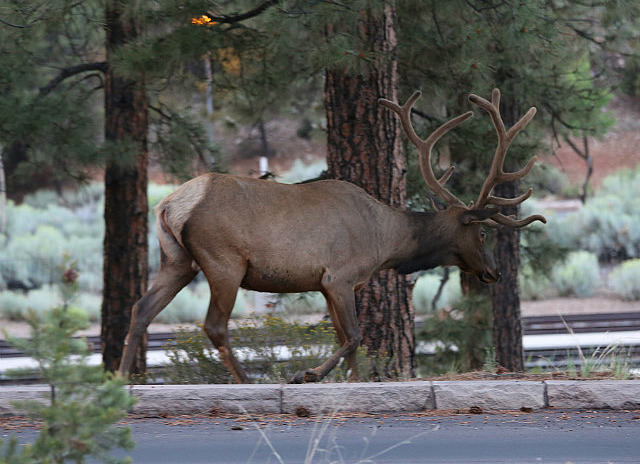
[5,411,640,464]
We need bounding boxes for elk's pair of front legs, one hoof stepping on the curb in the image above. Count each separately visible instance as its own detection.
[291,272,361,383]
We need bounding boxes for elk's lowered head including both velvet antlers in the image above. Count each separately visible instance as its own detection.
[379,89,547,283]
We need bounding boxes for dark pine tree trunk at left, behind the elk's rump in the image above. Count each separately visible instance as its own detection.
[101,1,148,373]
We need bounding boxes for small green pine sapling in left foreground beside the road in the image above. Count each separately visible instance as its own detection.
[0,267,134,464]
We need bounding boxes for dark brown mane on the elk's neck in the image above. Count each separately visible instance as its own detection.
[394,211,452,274]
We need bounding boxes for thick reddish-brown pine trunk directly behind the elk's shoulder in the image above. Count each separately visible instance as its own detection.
[324,5,415,377]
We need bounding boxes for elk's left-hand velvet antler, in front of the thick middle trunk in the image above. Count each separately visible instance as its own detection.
[378,90,473,206]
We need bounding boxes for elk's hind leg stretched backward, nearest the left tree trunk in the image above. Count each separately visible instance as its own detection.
[118,254,198,376]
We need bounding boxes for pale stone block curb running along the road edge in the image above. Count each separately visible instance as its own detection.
[0,380,640,416]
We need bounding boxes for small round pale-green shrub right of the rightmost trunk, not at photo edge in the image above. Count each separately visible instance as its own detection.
[553,251,600,298]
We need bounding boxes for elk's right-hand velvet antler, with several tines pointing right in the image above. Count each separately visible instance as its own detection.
[469,89,547,227]
